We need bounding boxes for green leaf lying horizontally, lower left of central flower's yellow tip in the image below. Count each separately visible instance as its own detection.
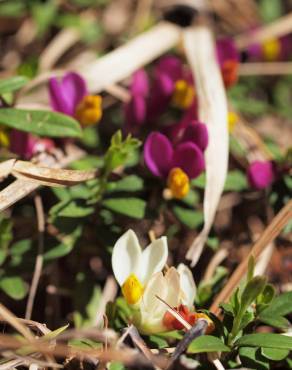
[102,198,146,219]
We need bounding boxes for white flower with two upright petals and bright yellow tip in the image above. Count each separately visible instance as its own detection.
[112,230,168,304]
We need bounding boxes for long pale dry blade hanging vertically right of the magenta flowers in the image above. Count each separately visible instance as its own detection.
[184,27,228,266]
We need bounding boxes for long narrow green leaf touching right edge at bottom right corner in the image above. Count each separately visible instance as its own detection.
[235,333,292,350]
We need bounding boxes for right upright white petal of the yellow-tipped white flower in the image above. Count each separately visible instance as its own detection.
[138,236,168,283]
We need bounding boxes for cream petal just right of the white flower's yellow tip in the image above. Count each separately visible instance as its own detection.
[140,272,168,321]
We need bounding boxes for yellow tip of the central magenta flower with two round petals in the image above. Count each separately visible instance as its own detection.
[167,167,190,199]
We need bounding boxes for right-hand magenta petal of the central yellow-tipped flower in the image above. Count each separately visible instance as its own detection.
[171,142,205,179]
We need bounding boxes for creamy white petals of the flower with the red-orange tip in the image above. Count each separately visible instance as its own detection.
[136,264,196,334]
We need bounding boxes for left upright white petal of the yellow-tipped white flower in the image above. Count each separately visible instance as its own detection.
[112,230,142,285]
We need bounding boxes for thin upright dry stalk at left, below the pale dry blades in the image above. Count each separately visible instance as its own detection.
[25,195,45,320]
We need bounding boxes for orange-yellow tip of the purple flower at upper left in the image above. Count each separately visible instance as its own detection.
[75,95,102,126]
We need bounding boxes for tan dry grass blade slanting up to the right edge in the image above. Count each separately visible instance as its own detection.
[210,200,292,315]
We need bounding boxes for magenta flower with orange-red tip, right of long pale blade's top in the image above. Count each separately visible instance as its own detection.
[216,38,239,88]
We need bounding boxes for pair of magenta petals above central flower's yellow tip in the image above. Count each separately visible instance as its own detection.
[144,132,205,179]
